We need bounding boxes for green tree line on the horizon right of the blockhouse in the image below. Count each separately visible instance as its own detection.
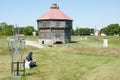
[71,24,120,36]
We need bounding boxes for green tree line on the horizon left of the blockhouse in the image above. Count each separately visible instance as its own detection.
[0,22,38,35]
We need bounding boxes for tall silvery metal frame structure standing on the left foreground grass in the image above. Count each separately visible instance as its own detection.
[8,25,25,78]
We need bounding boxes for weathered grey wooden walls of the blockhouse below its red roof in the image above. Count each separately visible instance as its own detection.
[38,21,72,44]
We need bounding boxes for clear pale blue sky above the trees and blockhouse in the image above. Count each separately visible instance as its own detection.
[0,0,120,29]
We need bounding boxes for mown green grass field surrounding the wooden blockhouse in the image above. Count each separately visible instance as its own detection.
[0,36,120,80]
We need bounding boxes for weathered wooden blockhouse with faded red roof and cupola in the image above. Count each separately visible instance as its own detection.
[37,3,73,44]
